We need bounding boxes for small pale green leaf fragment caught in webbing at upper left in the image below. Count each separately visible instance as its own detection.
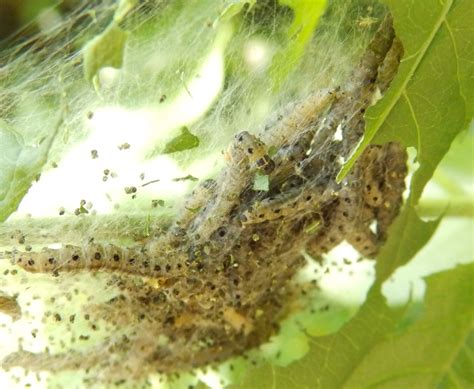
[83,23,128,82]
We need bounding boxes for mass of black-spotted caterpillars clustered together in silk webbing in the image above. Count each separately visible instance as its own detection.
[3,16,407,379]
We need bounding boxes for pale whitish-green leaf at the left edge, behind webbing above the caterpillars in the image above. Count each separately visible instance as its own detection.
[0,118,62,222]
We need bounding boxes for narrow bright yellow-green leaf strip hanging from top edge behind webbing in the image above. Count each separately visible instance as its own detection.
[269,0,326,90]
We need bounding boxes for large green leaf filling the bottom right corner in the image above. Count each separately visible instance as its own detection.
[234,264,474,389]
